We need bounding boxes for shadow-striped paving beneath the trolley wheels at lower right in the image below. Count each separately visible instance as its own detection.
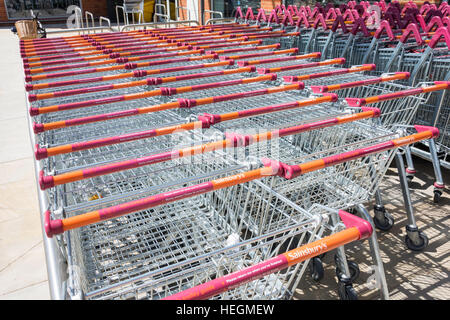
[295,158,450,300]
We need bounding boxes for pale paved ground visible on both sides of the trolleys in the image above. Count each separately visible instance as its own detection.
[0,29,450,300]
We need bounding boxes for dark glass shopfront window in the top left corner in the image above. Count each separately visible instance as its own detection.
[4,0,81,20]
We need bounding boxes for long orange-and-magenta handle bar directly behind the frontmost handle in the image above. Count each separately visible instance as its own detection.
[44,126,439,237]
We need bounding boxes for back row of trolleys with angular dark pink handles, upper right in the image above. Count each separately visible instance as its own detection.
[232,2,450,171]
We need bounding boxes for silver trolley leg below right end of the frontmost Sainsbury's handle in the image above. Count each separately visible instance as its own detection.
[356,205,389,300]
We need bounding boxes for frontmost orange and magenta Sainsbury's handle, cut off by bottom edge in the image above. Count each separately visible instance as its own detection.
[162,210,373,300]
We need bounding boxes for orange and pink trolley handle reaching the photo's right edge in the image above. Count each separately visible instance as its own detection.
[345,81,450,107]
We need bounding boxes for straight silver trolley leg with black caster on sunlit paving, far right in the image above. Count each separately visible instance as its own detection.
[395,152,428,251]
